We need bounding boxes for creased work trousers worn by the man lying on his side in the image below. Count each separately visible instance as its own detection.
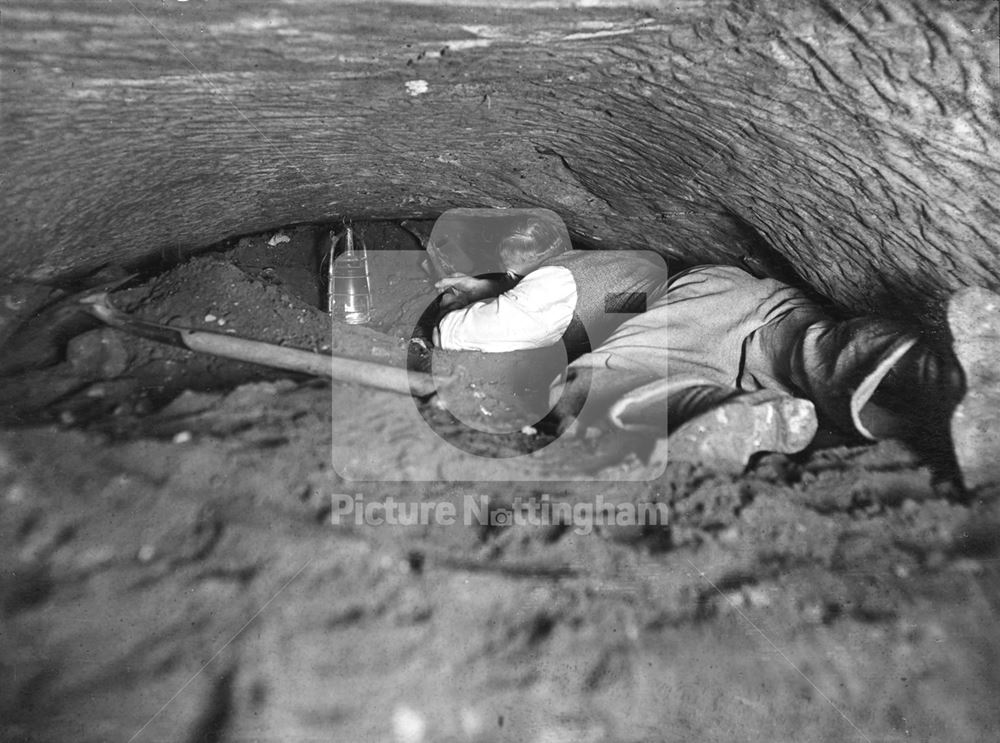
[552,266,918,438]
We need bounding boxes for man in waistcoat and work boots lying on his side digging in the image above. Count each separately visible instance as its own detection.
[426,218,1000,488]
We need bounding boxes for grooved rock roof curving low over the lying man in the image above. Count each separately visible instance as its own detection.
[0,0,1000,320]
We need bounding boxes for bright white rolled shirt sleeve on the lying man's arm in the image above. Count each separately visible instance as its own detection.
[434,266,577,352]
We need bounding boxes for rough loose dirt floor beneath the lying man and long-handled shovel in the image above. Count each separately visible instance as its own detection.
[0,223,1000,743]
